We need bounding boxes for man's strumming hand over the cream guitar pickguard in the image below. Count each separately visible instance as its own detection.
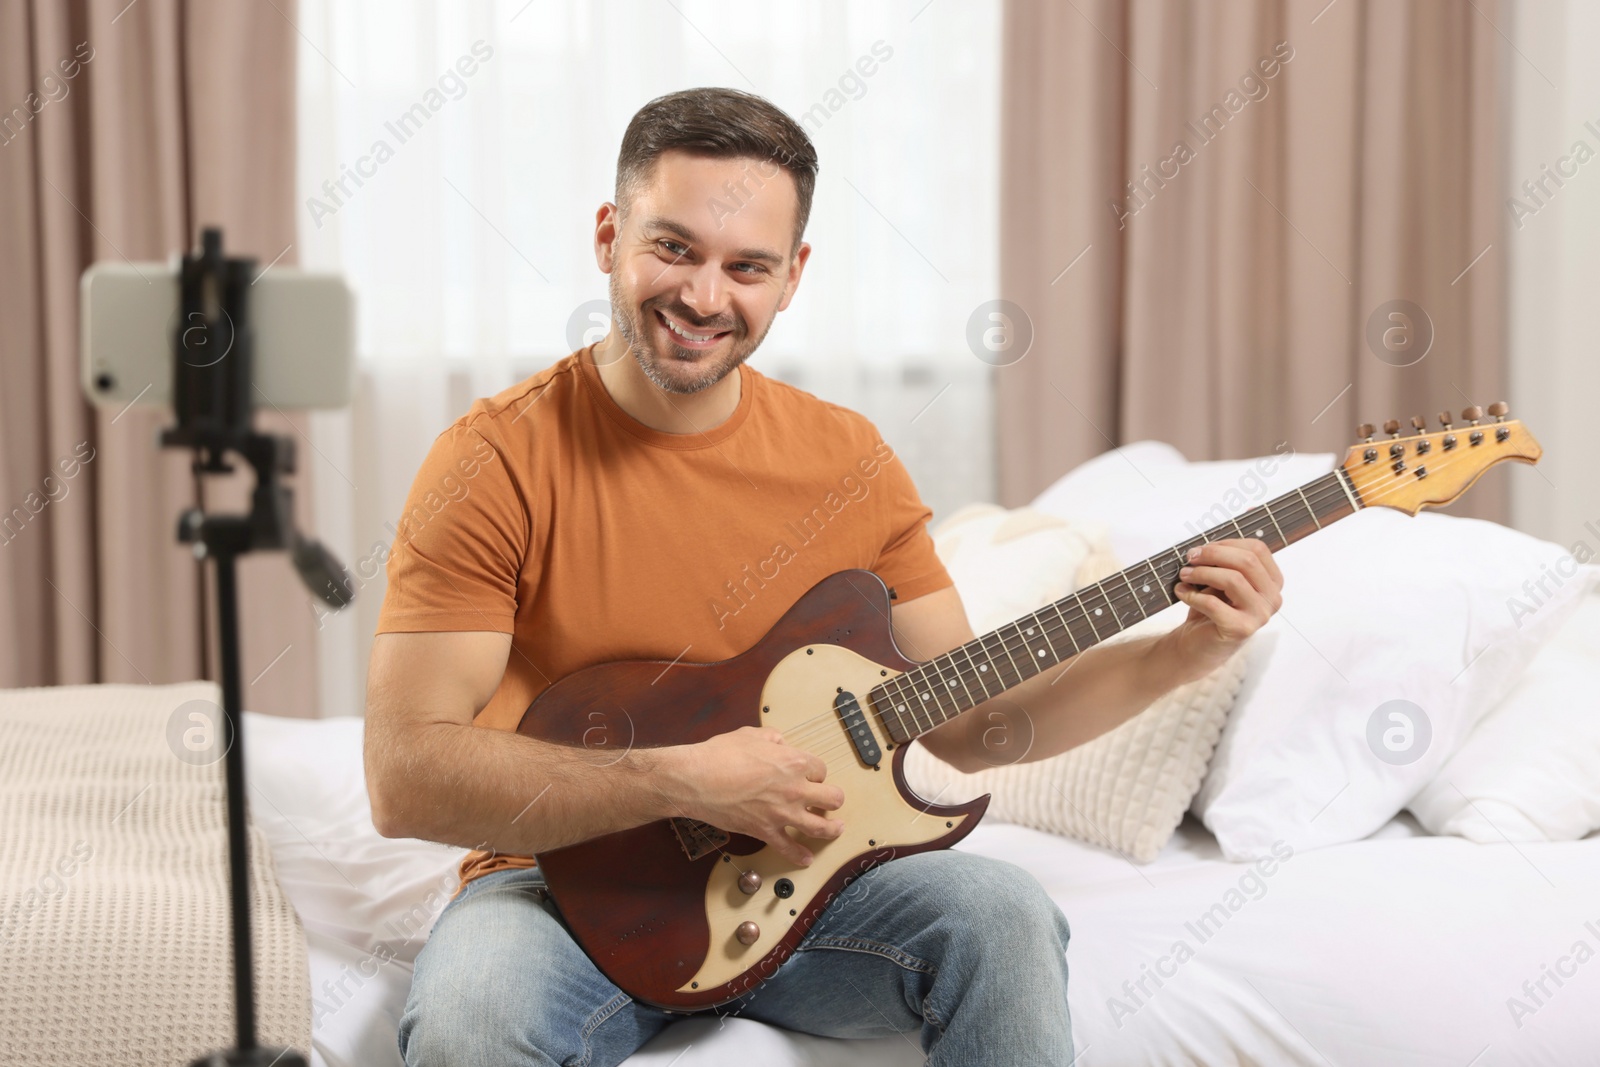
[661,726,845,867]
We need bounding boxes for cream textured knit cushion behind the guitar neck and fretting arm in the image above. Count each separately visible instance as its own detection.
[906,506,1246,864]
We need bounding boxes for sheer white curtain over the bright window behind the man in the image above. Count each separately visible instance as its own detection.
[296,0,1000,715]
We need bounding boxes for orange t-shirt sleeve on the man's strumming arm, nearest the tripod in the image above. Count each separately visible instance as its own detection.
[376,424,530,633]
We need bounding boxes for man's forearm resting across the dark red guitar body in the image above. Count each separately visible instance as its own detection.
[366,723,677,856]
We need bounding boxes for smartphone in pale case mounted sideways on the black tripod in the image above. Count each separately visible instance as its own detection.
[78,259,355,411]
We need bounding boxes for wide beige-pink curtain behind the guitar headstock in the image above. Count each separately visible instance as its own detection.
[997,0,1517,520]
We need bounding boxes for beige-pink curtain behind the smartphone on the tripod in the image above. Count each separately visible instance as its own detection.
[0,0,317,715]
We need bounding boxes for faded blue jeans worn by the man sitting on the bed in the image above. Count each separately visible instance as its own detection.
[400,849,1074,1067]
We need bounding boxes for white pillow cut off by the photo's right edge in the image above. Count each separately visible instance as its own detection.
[1408,595,1600,843]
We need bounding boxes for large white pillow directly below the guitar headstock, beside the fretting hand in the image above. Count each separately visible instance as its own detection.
[1195,509,1600,861]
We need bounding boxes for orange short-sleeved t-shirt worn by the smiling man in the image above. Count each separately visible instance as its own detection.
[378,347,950,891]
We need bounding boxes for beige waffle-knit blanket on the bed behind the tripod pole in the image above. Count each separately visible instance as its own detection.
[0,681,310,1067]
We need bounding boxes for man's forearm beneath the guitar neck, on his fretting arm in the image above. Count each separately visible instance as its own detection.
[923,635,1189,773]
